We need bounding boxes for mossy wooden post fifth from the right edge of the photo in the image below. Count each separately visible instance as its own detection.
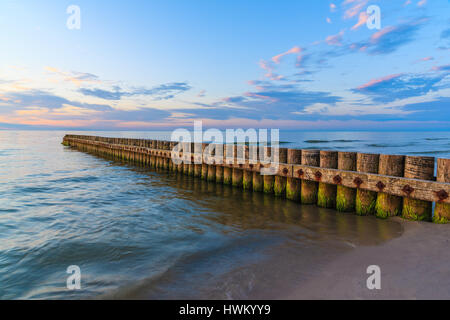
[336,152,356,212]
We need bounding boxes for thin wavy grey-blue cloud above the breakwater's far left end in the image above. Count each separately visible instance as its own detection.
[78,82,191,100]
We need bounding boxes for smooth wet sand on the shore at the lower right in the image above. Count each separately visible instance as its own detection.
[280,218,450,299]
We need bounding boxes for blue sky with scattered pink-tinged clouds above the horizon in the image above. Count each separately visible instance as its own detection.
[0,0,450,131]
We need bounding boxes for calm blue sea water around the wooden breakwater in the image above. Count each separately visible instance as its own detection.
[0,131,450,299]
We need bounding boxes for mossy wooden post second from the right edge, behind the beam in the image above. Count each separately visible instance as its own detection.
[402,156,435,221]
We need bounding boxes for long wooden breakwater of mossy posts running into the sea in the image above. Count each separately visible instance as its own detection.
[63,135,450,223]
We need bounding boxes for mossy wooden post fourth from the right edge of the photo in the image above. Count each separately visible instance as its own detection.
[355,153,380,216]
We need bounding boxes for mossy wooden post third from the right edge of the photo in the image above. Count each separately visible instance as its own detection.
[375,154,405,219]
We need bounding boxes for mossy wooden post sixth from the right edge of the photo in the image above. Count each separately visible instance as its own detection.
[317,151,338,208]
